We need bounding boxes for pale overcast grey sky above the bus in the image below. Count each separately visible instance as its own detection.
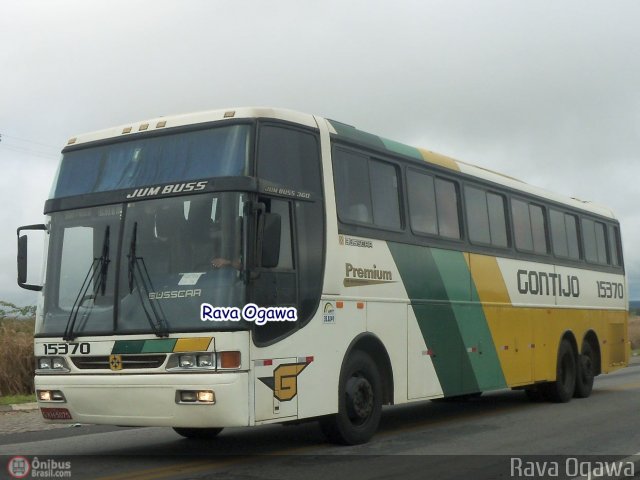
[0,0,640,305]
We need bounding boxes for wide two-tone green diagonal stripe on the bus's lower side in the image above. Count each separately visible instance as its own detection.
[388,243,506,396]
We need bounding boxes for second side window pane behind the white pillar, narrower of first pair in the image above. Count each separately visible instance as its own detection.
[369,160,401,229]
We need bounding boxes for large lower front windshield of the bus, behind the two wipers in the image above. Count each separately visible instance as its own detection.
[37,192,248,339]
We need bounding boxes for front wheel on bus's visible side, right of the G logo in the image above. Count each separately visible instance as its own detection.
[320,350,382,445]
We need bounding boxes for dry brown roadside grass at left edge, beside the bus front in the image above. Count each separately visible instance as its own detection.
[0,318,35,399]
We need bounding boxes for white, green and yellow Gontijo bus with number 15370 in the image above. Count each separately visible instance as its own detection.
[18,108,629,444]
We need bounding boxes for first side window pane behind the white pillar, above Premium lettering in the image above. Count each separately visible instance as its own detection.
[333,148,373,223]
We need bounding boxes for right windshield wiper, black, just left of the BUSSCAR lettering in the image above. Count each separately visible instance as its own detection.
[127,222,169,337]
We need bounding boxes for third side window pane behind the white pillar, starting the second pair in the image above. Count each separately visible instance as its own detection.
[407,169,438,235]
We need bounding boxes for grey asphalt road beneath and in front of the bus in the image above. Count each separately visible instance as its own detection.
[0,364,640,480]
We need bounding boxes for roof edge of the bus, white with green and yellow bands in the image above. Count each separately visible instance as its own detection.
[67,107,615,218]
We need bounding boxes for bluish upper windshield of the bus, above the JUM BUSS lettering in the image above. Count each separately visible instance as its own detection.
[51,124,252,198]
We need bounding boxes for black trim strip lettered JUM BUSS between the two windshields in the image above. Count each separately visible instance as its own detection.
[44,176,258,215]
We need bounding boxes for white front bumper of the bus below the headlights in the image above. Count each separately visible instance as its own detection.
[35,372,249,428]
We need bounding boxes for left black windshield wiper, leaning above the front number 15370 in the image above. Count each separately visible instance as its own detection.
[62,225,111,342]
